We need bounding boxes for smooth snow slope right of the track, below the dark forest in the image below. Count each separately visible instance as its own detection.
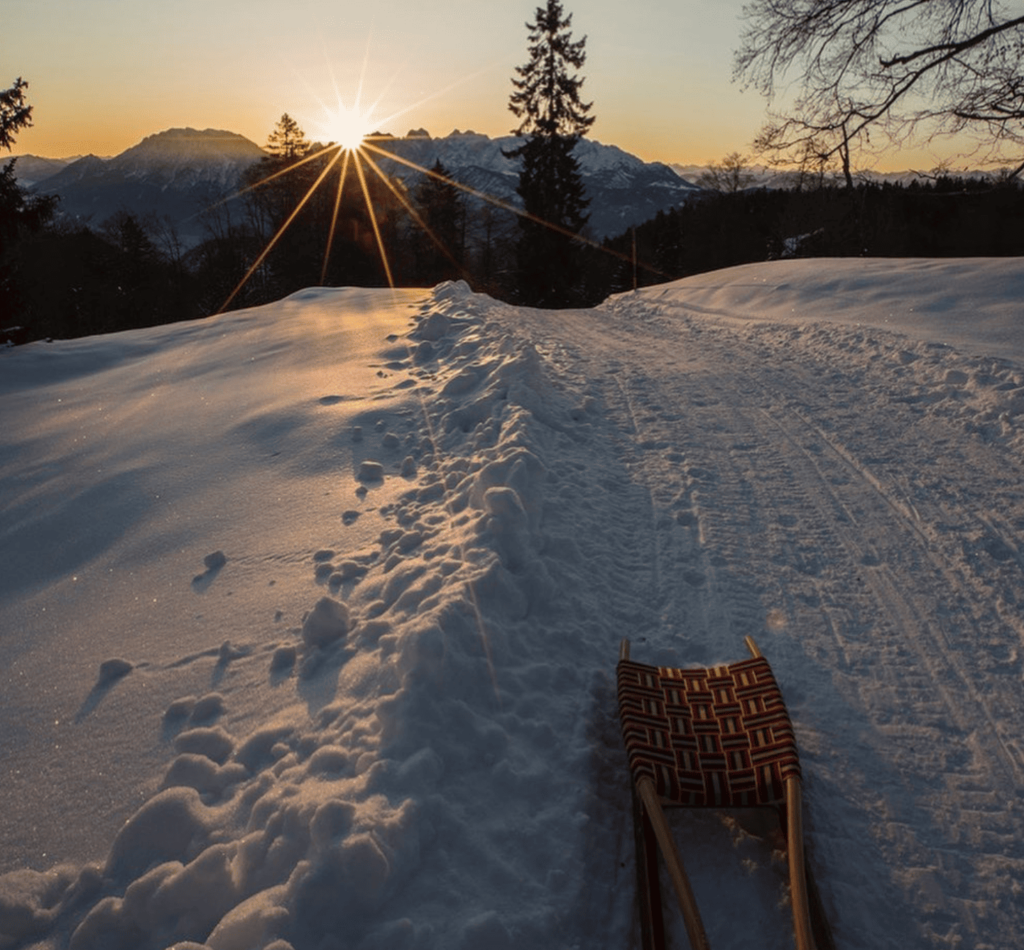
[630,258,1024,451]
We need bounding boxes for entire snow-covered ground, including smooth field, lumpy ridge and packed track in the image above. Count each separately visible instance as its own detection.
[0,260,1024,950]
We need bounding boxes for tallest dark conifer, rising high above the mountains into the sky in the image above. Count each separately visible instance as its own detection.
[509,0,594,307]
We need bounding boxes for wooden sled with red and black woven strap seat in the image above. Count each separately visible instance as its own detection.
[617,637,833,950]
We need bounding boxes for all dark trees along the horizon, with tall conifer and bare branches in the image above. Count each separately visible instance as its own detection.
[6,0,1024,339]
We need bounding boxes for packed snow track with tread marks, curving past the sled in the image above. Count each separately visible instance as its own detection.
[501,298,1024,947]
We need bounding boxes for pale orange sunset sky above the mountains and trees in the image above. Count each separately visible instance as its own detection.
[0,0,974,170]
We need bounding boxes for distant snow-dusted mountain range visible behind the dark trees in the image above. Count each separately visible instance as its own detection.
[15,129,699,246]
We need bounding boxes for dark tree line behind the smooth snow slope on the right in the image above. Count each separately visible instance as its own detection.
[604,176,1024,294]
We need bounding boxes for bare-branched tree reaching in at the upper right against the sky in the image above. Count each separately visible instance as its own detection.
[735,0,1024,180]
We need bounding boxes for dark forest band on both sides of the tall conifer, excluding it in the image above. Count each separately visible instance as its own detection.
[0,147,1024,342]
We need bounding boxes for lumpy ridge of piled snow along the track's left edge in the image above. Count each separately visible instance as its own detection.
[0,285,626,950]
